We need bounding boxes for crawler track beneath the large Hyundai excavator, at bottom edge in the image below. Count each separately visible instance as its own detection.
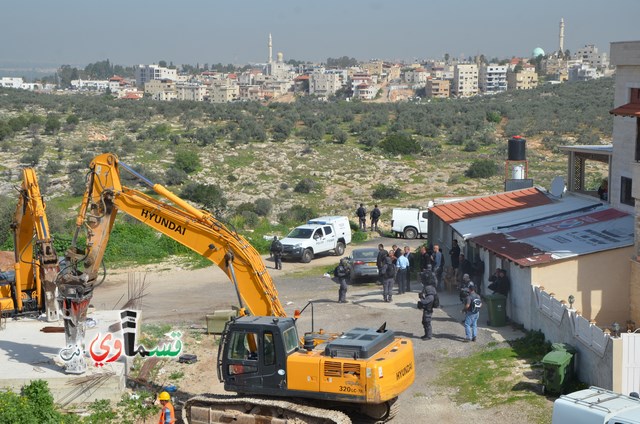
[182,394,352,424]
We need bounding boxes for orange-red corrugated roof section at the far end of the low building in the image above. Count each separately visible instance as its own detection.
[430,187,551,224]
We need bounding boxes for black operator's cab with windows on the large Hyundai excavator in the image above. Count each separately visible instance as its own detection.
[218,316,300,395]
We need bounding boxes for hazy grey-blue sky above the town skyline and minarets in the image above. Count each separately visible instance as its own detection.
[0,0,640,66]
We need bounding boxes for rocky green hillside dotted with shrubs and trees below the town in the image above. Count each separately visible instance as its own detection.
[0,77,613,262]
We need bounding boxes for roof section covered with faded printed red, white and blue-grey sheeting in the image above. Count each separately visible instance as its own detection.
[472,205,634,266]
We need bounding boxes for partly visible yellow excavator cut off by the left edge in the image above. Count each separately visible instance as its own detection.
[0,168,58,321]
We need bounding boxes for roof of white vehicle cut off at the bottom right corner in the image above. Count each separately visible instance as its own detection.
[551,386,640,424]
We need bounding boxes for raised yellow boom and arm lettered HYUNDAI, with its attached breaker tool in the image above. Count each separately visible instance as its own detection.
[59,153,285,373]
